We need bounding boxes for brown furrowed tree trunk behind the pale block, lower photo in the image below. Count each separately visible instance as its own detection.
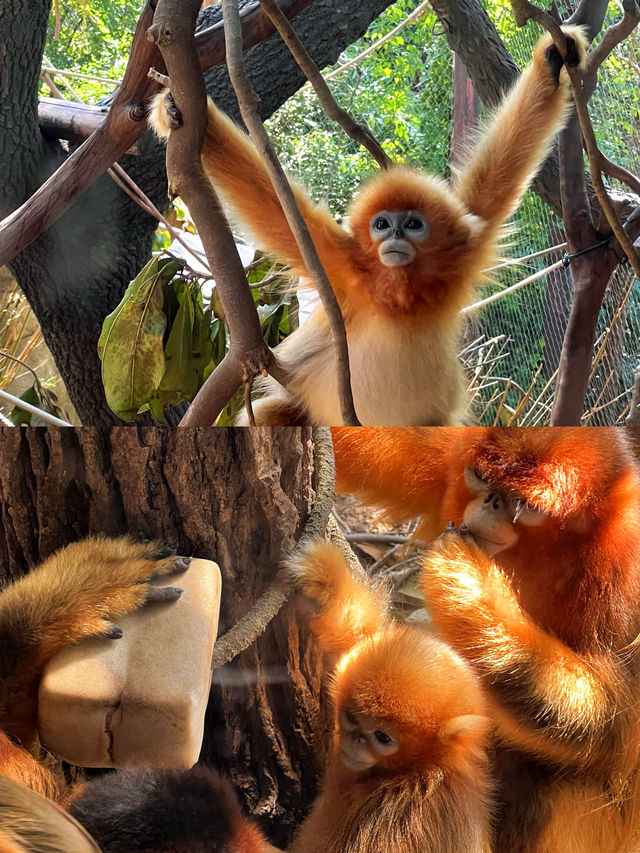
[0,427,330,846]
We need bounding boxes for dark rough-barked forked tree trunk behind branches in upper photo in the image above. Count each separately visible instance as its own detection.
[0,0,392,425]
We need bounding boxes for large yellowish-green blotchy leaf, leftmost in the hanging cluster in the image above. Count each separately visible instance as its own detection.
[98,257,182,421]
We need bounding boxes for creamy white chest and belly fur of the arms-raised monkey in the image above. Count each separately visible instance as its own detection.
[258,308,464,426]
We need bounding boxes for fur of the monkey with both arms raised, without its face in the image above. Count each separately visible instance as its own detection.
[149,28,585,425]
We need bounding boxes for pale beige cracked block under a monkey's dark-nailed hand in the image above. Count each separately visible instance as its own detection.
[38,559,221,768]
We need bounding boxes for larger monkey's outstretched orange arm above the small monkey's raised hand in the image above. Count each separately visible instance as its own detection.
[331,427,458,541]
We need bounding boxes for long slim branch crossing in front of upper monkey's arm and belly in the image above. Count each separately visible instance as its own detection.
[222,0,359,426]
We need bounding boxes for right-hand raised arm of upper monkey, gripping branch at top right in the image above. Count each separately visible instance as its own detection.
[456,27,586,233]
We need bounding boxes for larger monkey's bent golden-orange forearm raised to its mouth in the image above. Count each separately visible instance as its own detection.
[422,534,637,773]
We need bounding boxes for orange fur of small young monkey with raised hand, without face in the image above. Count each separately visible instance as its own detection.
[292,543,489,853]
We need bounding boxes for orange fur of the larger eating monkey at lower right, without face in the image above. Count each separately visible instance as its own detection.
[334,428,640,853]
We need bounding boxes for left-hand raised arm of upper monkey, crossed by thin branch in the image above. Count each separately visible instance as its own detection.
[149,92,357,291]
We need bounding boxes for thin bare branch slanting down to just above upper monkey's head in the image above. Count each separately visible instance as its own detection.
[260,0,392,169]
